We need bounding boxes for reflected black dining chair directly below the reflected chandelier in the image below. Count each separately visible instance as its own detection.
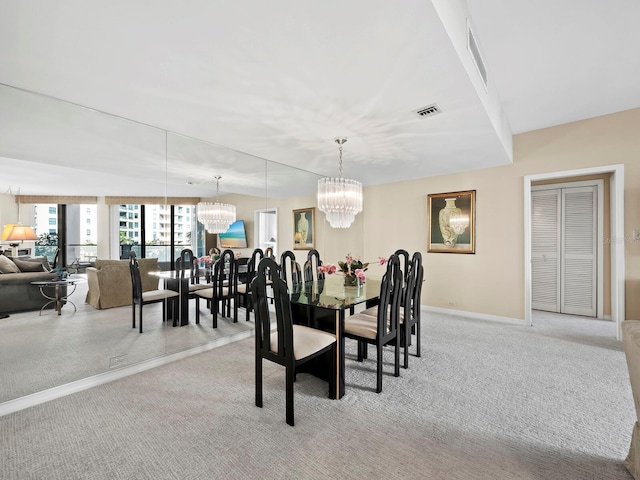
[195,249,238,328]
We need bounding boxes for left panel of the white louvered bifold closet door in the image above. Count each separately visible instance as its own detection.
[531,189,562,312]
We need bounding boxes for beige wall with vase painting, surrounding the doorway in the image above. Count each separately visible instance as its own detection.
[362,109,640,319]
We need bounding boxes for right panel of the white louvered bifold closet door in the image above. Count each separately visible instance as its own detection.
[560,187,597,317]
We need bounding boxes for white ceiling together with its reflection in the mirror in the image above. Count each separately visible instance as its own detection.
[0,0,640,196]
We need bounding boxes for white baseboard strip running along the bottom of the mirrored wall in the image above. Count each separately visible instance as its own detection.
[0,328,255,417]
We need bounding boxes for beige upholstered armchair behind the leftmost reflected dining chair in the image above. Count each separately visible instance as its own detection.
[86,258,160,309]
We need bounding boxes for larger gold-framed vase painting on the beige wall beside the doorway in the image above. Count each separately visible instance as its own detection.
[427,190,476,253]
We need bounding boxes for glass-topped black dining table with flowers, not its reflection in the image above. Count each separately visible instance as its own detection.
[290,275,380,398]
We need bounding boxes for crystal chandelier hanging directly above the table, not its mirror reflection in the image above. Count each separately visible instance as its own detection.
[318,137,362,228]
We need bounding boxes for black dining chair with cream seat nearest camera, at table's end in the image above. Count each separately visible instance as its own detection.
[251,258,336,426]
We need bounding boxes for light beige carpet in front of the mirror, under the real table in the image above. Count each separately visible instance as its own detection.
[0,314,635,480]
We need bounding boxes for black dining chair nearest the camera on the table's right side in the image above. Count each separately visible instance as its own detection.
[344,255,402,393]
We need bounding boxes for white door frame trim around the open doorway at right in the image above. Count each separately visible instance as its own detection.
[523,164,625,340]
